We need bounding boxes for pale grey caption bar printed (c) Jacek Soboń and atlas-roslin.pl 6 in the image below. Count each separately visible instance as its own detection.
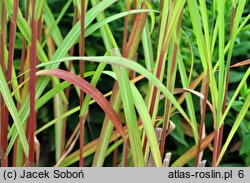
[0,167,250,183]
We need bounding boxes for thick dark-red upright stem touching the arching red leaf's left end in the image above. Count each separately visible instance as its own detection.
[28,0,37,166]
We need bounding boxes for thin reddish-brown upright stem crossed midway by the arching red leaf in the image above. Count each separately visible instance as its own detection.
[79,0,85,167]
